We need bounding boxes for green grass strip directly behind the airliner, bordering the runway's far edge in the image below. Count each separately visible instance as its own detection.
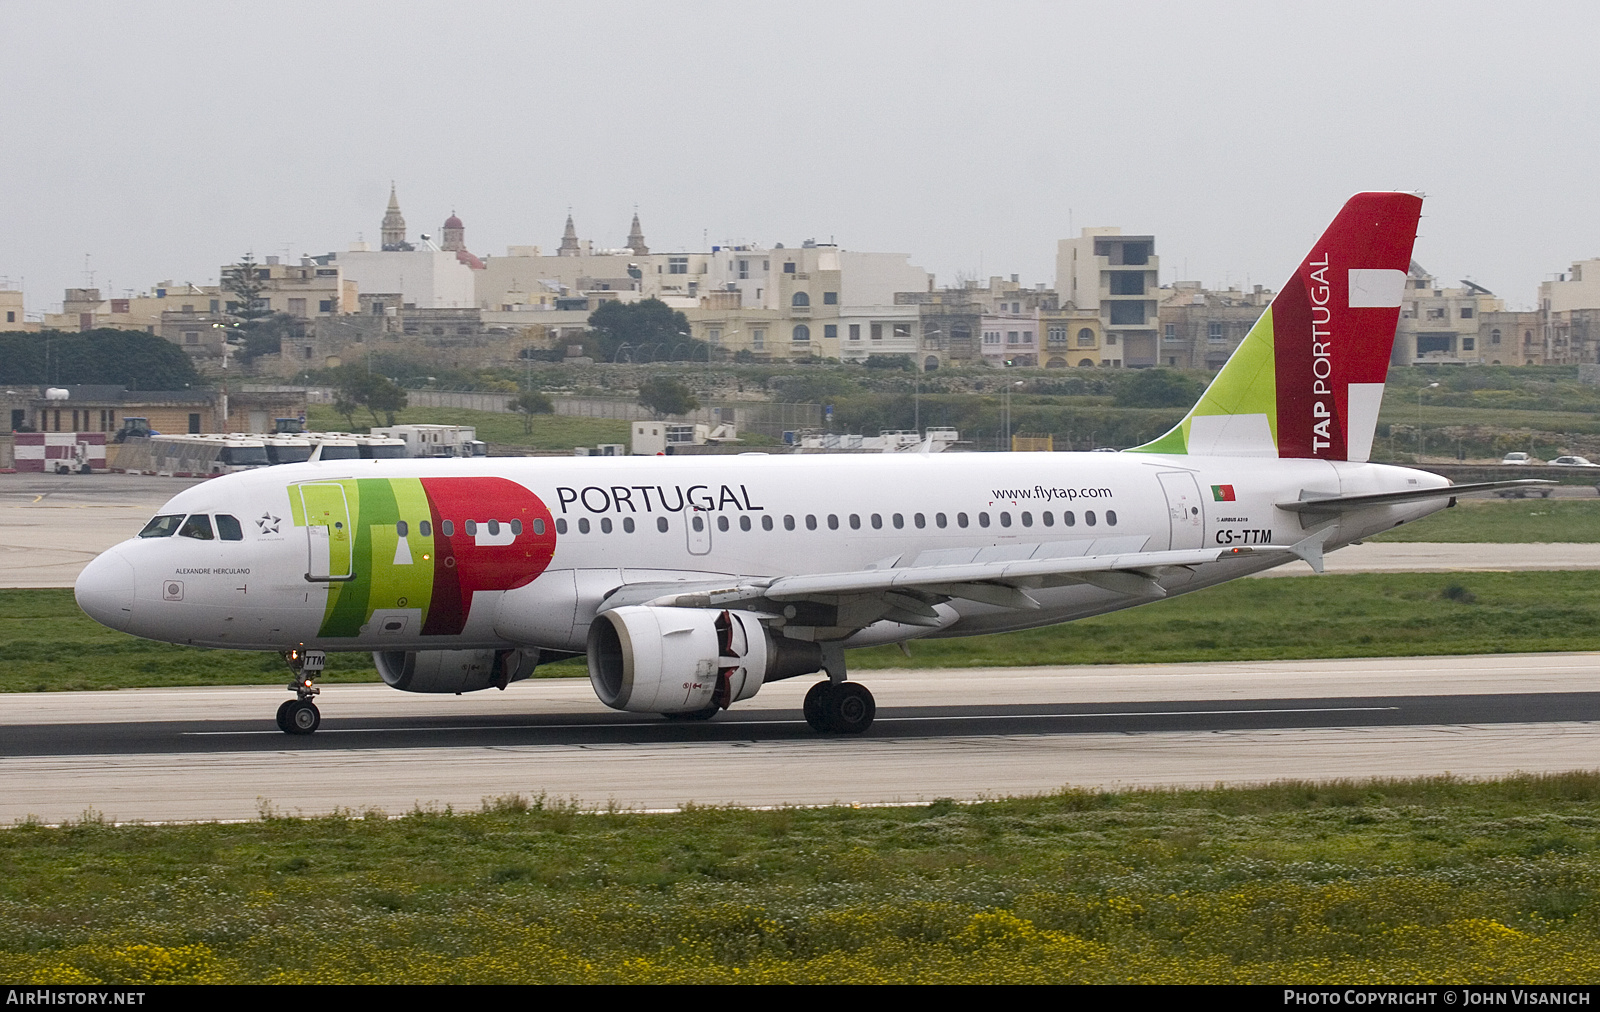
[12,572,1600,692]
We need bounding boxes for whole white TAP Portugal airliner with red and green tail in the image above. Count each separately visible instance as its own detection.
[77,192,1536,735]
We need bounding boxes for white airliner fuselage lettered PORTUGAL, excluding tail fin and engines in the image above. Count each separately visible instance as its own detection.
[78,453,1446,652]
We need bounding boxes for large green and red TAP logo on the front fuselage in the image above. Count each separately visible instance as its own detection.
[290,477,555,637]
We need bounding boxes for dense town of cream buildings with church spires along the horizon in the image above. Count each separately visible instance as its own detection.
[12,184,1600,376]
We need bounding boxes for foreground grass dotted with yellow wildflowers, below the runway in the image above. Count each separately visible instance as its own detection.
[0,772,1600,985]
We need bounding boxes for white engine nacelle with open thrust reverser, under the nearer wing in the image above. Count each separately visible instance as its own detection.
[589,605,822,713]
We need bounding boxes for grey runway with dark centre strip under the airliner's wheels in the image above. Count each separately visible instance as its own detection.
[0,653,1600,823]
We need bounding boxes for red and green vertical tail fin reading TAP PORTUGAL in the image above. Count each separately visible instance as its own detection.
[1134,194,1422,461]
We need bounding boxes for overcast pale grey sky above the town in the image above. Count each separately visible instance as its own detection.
[0,0,1600,312]
